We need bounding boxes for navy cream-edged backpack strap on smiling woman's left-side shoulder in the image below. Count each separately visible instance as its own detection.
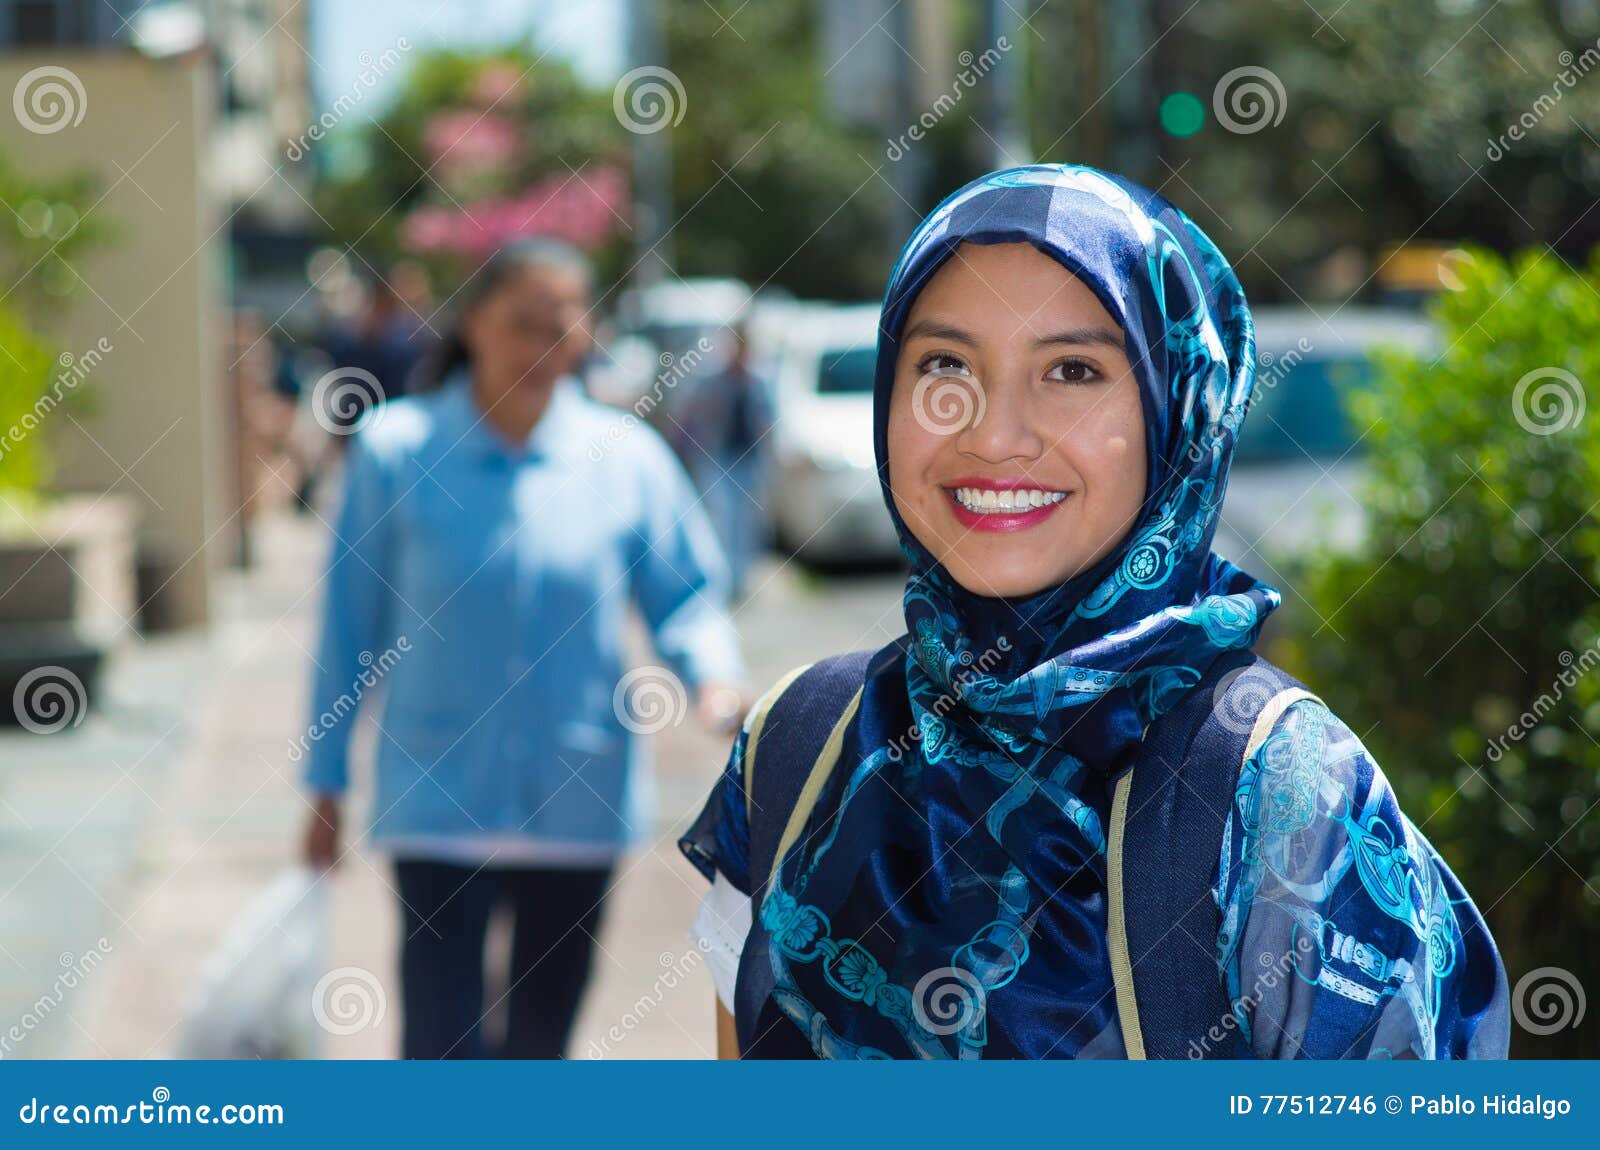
[744,651,875,902]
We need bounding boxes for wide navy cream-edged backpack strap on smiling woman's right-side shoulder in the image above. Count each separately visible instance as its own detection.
[1107,651,1317,1059]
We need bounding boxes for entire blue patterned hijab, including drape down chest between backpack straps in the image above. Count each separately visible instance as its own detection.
[739,165,1278,1057]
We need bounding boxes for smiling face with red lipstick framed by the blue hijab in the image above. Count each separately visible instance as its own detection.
[888,243,1147,597]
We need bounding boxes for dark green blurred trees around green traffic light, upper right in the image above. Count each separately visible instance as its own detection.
[1026,0,1600,302]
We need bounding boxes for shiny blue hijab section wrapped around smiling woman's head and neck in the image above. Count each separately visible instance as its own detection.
[874,165,1278,783]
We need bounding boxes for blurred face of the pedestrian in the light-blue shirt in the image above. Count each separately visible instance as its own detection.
[462,267,589,400]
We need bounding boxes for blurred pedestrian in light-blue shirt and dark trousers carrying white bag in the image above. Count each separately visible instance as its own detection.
[304,240,744,1059]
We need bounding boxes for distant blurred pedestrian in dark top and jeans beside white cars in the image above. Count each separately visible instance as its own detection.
[674,325,774,597]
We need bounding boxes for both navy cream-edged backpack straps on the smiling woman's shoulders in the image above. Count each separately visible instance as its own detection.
[736,638,1315,1059]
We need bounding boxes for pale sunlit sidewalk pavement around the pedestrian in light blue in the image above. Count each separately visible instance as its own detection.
[0,512,901,1059]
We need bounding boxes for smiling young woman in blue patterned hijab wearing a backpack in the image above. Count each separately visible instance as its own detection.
[682,165,1509,1059]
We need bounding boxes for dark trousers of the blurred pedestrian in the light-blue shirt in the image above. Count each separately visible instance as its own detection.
[395,859,611,1059]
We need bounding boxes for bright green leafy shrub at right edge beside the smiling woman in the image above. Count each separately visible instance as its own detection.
[1275,253,1600,1057]
